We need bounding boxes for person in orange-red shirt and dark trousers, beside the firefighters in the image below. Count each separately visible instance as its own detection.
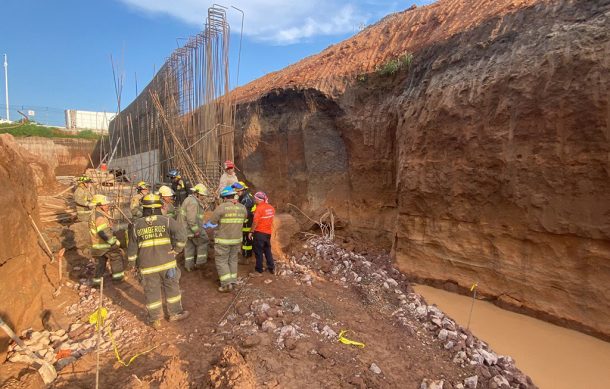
[250,192,275,274]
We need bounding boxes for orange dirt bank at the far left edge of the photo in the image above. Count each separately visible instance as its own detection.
[0,134,50,359]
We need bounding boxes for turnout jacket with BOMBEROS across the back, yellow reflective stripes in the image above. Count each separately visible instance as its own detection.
[127,215,186,275]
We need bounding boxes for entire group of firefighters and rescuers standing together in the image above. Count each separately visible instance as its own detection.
[74,161,275,329]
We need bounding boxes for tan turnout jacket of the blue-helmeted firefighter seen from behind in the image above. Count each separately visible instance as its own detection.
[210,201,248,245]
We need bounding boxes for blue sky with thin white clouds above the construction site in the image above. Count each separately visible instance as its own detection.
[0,0,431,125]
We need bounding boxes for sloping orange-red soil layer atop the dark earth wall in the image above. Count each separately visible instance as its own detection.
[233,0,544,103]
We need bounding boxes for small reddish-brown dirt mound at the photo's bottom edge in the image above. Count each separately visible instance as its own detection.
[208,346,258,389]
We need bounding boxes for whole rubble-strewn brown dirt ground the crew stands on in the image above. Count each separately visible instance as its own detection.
[0,183,534,389]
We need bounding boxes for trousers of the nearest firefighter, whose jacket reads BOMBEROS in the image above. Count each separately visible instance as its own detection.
[142,267,182,322]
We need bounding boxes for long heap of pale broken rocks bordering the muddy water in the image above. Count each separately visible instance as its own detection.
[279,238,535,389]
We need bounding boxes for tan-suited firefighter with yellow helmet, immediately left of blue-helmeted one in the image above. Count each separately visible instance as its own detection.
[178,184,209,271]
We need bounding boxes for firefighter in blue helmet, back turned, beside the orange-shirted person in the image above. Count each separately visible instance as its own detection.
[206,186,248,292]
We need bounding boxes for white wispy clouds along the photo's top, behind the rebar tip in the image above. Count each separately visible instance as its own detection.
[120,0,404,44]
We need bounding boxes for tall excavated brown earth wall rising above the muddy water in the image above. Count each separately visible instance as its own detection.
[236,0,610,337]
